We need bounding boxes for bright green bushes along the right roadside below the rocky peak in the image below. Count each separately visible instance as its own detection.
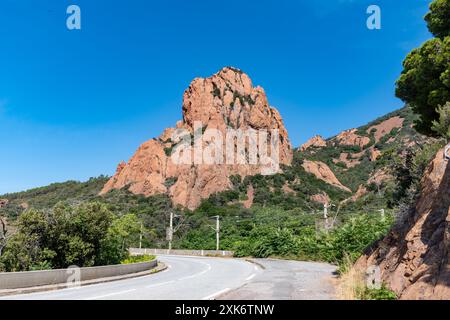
[236,214,393,264]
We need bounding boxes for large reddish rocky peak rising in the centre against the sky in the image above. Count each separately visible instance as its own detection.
[101,67,293,209]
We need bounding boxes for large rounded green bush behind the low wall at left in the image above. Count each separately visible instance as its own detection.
[0,202,142,271]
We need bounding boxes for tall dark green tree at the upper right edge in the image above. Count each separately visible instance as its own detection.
[396,0,450,135]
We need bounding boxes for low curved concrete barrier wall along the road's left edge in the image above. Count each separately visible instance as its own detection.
[0,259,158,290]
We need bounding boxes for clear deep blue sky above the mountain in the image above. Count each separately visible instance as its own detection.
[0,0,430,194]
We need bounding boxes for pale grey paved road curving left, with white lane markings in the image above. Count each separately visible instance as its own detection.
[2,256,334,300]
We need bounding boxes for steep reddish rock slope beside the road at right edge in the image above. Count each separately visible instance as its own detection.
[356,150,450,300]
